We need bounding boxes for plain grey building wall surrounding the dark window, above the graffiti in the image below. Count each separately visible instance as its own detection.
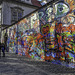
[2,2,35,25]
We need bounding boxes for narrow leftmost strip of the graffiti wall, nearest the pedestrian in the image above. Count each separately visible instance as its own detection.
[7,25,17,53]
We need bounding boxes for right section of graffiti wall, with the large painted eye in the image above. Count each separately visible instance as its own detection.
[39,0,75,66]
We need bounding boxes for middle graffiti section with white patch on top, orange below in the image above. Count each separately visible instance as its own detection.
[18,14,44,60]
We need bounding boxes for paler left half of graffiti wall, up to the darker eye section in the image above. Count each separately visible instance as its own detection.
[7,12,44,60]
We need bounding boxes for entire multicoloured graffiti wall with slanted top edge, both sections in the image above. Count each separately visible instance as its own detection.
[1,0,75,68]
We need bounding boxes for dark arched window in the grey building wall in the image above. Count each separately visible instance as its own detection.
[11,7,23,23]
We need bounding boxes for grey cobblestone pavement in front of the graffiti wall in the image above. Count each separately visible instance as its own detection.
[0,53,75,75]
